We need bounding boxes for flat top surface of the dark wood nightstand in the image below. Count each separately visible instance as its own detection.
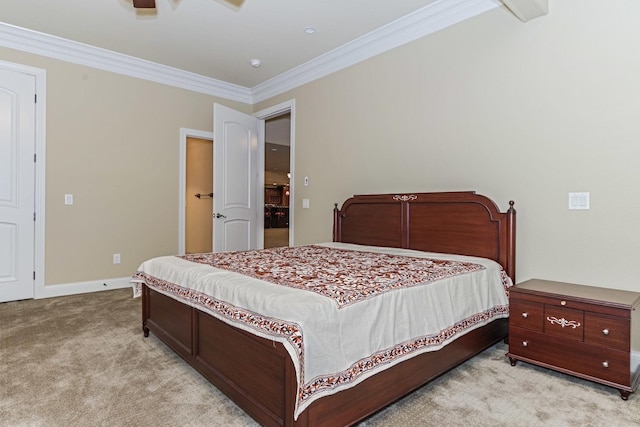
[515,279,640,308]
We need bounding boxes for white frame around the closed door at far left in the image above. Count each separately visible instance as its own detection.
[0,61,47,298]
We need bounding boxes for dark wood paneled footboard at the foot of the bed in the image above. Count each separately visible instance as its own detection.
[142,285,296,426]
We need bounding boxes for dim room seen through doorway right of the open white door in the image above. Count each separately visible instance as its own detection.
[264,112,291,248]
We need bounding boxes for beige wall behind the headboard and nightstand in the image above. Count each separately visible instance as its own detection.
[254,0,640,291]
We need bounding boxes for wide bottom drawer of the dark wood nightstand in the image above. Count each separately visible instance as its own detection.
[509,328,631,386]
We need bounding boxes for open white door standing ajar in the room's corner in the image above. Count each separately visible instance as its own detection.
[213,104,258,252]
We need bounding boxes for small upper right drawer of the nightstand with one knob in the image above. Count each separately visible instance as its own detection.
[584,312,631,351]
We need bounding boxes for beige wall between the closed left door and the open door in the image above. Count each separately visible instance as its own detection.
[0,48,251,285]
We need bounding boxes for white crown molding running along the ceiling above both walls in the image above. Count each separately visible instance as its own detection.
[0,0,502,104]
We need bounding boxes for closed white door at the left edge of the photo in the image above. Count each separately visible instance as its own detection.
[0,68,36,302]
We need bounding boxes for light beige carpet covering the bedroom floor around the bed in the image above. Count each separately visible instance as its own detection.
[0,289,640,427]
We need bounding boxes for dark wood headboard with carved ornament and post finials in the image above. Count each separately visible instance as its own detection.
[333,191,516,283]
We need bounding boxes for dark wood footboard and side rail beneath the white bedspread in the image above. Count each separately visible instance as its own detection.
[142,285,507,426]
